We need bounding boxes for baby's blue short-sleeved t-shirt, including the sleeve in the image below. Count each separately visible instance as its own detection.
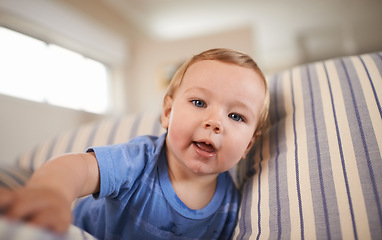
[74,134,240,239]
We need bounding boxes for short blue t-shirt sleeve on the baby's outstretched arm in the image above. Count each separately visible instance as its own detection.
[87,135,165,199]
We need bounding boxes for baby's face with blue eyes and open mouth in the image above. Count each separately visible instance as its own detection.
[162,60,265,174]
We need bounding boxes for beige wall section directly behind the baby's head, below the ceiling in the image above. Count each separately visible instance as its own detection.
[130,27,253,112]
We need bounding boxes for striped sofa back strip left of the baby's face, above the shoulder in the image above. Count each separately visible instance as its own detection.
[18,112,165,179]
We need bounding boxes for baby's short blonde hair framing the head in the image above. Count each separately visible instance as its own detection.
[165,48,269,138]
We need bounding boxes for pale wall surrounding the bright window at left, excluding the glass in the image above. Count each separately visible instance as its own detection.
[0,0,129,164]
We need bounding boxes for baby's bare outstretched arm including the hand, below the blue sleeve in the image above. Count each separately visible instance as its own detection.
[0,153,99,233]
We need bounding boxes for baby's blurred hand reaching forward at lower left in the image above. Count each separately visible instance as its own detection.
[0,187,71,233]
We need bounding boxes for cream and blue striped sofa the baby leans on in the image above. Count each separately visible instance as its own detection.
[0,52,382,239]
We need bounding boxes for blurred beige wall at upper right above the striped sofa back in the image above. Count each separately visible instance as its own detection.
[250,0,382,72]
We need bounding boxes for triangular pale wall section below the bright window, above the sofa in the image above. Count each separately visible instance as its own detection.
[0,95,102,165]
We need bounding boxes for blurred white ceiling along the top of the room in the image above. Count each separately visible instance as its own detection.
[102,0,368,40]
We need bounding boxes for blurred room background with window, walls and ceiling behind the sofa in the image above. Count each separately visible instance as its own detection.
[0,0,382,163]
